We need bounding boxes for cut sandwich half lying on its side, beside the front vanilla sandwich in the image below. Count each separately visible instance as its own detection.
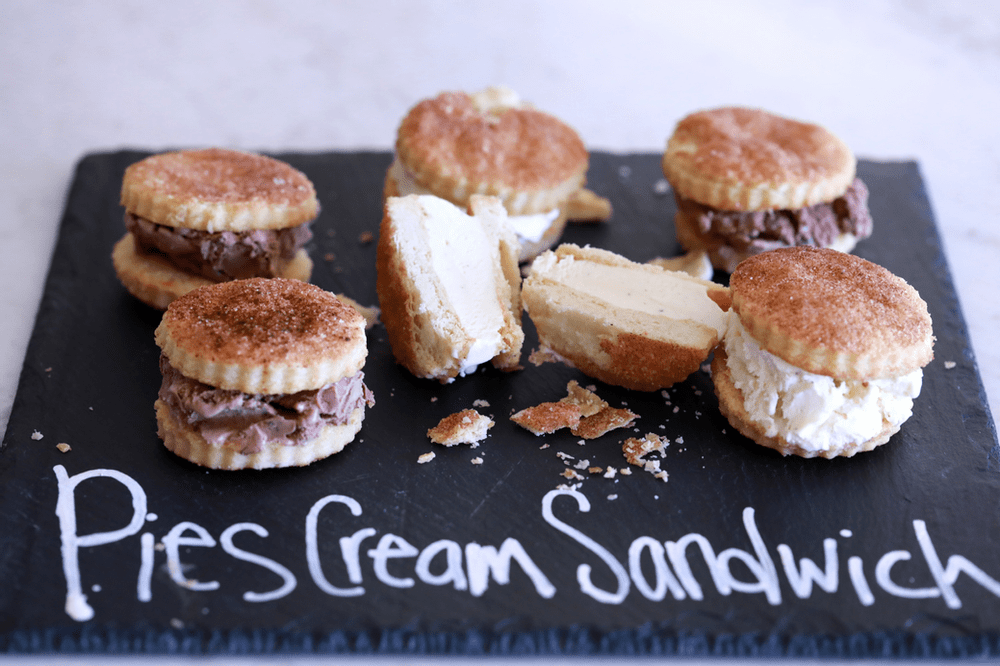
[521,244,729,391]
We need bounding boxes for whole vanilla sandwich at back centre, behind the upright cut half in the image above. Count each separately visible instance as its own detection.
[385,87,611,261]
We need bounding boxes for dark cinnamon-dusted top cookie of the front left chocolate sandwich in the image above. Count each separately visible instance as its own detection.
[156,278,368,394]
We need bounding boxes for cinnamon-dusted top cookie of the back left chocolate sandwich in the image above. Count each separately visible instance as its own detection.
[121,148,319,232]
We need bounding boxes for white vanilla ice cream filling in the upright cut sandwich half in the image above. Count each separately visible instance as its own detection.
[400,196,504,375]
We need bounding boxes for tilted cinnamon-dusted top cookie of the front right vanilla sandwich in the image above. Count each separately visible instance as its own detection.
[729,247,934,380]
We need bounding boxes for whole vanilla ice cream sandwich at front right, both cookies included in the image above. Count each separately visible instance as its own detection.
[712,247,934,458]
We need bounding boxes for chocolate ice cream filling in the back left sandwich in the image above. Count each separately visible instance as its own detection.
[125,212,312,282]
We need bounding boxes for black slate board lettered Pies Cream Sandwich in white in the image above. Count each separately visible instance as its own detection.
[0,152,1000,657]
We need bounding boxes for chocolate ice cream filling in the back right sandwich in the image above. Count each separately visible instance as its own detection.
[674,178,872,254]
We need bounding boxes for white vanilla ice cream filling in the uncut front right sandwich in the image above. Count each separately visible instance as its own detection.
[725,311,923,451]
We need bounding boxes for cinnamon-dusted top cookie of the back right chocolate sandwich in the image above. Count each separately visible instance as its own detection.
[663,108,856,211]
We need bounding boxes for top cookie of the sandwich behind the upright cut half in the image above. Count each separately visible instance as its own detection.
[396,92,588,215]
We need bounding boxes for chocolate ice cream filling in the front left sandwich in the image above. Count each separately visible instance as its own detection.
[159,355,375,454]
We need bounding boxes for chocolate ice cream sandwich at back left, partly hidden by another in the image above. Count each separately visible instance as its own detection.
[112,148,319,309]
